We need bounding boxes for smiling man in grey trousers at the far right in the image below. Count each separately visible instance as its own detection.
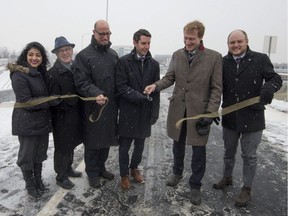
[213,30,282,207]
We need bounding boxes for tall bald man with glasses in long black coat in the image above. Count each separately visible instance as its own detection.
[72,20,118,188]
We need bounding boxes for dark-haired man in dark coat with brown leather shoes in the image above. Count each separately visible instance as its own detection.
[116,29,160,190]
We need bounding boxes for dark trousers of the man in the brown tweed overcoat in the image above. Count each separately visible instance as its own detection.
[173,124,206,189]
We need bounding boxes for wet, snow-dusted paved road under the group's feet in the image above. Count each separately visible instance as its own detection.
[0,93,287,216]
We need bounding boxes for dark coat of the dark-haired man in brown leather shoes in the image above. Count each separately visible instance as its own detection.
[116,49,160,139]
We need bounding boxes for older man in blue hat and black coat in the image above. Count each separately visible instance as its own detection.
[46,36,83,189]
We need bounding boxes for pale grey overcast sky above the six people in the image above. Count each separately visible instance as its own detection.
[0,0,288,63]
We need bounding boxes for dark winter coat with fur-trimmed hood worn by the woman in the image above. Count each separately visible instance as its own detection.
[8,65,52,136]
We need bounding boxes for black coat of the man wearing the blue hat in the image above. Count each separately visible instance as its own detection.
[46,60,83,153]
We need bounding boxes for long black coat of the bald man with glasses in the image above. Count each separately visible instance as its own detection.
[72,36,118,149]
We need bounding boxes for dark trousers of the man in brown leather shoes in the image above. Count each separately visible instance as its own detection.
[119,136,145,177]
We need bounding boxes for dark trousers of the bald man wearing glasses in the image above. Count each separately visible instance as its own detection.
[84,147,110,178]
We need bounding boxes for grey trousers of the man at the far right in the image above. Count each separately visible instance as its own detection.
[223,127,263,187]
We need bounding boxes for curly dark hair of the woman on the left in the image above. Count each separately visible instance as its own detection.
[17,42,49,74]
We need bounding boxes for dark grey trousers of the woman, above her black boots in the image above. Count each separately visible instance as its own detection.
[17,133,49,171]
